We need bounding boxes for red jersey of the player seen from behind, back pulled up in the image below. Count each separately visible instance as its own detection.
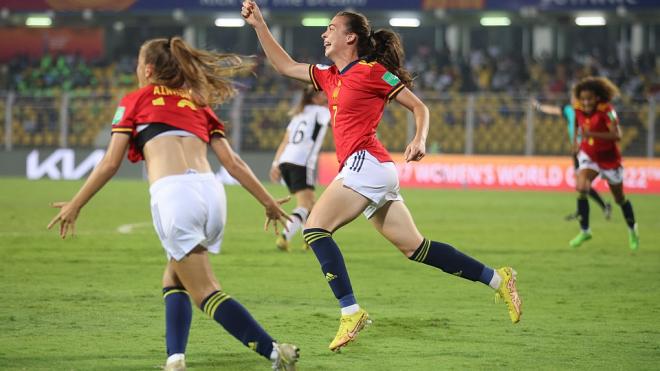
[112,85,225,162]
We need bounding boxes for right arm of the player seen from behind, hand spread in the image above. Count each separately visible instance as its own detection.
[211,137,289,233]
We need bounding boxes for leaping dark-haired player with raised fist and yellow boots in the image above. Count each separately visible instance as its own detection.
[241,1,521,351]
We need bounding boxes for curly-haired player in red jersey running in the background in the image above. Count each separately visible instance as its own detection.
[569,77,639,251]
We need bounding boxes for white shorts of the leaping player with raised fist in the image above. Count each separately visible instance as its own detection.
[335,150,403,219]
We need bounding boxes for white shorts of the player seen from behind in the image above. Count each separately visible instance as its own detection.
[149,171,227,261]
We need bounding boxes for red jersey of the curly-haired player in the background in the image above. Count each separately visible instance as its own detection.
[575,103,621,170]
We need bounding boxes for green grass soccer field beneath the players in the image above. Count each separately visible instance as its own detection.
[0,178,660,371]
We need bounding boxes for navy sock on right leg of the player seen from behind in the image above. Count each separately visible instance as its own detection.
[200,290,275,359]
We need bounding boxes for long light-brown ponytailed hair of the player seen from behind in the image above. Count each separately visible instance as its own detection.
[142,36,254,107]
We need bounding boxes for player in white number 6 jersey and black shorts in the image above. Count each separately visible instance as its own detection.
[270,86,330,251]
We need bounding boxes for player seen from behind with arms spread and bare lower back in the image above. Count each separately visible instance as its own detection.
[48,37,298,371]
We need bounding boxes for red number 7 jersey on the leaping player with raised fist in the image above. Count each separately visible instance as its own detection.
[309,60,404,168]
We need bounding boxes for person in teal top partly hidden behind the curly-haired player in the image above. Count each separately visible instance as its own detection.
[532,99,612,221]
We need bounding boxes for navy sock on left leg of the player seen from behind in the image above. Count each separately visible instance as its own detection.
[163,286,192,356]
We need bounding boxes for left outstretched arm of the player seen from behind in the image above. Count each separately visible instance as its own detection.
[48,134,130,239]
